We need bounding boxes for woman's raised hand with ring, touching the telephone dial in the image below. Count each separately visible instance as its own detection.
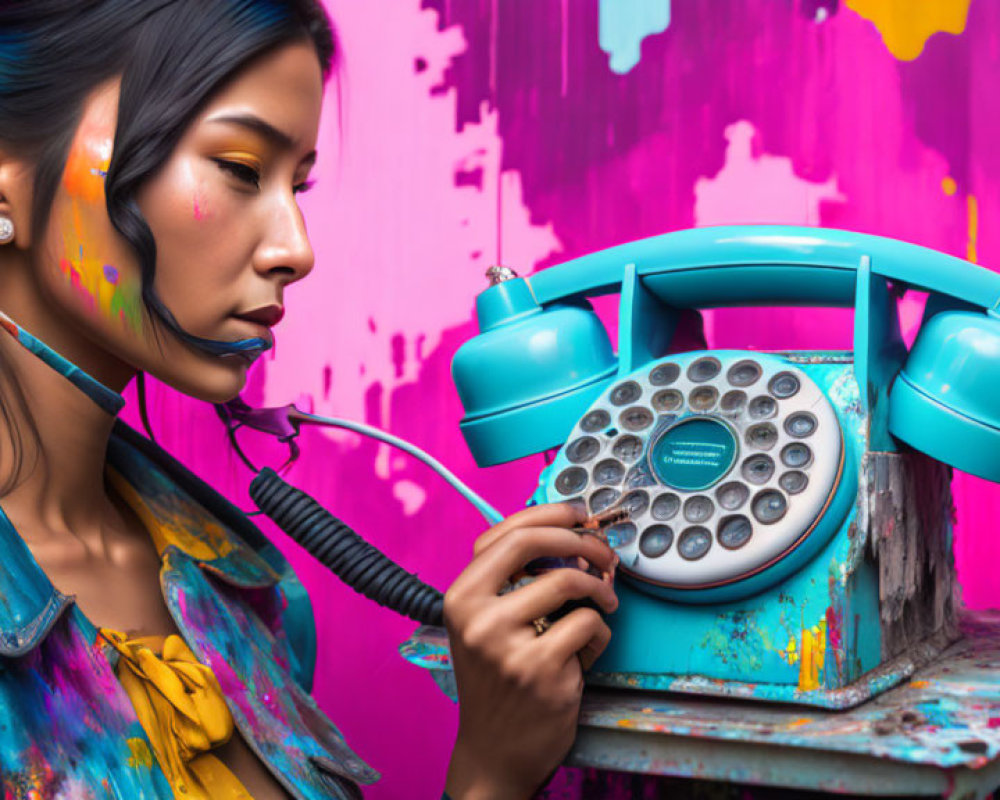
[444,504,618,800]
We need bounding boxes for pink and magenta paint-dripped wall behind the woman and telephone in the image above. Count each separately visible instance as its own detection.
[123,0,1000,798]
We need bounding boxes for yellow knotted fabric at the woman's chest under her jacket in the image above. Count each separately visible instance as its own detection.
[100,628,253,800]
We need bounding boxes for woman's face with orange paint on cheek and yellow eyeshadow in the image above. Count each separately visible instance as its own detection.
[38,41,323,401]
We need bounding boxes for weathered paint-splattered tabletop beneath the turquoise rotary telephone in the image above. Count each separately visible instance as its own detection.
[403,611,1000,798]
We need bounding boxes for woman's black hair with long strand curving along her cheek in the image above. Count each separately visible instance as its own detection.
[0,0,338,493]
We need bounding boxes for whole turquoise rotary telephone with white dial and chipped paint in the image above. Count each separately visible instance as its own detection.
[453,226,1000,708]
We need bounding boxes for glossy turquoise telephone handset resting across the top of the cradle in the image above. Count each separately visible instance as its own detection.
[453,225,1000,481]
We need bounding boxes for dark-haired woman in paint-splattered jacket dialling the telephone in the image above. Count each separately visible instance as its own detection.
[0,0,617,800]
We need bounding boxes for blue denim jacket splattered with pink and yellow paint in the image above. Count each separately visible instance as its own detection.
[0,424,378,800]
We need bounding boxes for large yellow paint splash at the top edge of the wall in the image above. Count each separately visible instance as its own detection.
[847,0,970,61]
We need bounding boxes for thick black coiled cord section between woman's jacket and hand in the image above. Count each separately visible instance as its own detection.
[250,467,444,625]
